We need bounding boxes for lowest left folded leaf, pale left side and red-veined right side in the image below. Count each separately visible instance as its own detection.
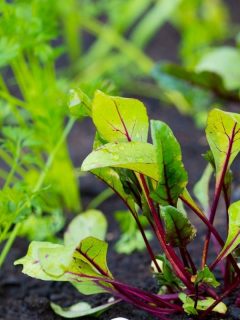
[14,237,111,294]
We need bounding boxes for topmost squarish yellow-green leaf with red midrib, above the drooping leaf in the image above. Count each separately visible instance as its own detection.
[92,91,149,142]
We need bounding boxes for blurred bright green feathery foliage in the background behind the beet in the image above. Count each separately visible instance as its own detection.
[0,0,240,264]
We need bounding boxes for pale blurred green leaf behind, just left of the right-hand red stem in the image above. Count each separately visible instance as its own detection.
[193,164,213,212]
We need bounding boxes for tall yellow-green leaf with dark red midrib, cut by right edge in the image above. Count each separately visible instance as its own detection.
[206,109,240,185]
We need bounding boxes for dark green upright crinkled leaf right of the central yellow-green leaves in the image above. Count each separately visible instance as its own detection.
[151,121,188,206]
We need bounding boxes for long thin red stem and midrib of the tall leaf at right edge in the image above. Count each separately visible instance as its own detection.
[202,122,237,267]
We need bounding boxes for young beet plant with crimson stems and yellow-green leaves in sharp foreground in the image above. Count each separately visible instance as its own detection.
[16,91,240,319]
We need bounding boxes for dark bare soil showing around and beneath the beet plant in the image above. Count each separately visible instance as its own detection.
[0,0,240,320]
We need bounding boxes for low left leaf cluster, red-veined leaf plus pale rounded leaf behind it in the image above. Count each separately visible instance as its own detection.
[15,210,111,294]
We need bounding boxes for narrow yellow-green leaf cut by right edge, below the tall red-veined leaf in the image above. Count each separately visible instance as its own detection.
[219,201,240,259]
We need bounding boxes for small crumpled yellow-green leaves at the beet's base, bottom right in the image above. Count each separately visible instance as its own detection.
[179,293,227,315]
